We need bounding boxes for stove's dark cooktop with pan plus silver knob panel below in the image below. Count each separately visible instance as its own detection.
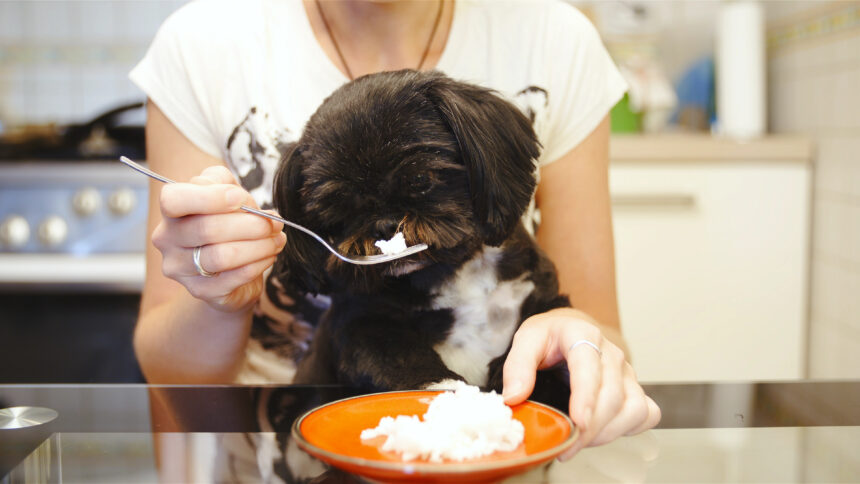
[0,102,148,293]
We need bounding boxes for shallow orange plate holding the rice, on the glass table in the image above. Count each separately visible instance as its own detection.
[292,390,574,482]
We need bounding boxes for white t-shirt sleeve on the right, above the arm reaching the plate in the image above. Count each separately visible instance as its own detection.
[539,4,627,165]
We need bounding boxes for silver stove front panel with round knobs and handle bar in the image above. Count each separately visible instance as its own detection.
[0,161,148,291]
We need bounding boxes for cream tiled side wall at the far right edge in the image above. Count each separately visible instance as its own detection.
[768,1,860,378]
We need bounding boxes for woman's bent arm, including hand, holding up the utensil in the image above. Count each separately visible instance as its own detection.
[134,101,284,383]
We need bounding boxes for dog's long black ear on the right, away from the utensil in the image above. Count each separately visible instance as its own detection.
[427,75,540,245]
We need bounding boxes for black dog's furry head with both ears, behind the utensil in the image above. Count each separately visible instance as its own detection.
[274,70,539,292]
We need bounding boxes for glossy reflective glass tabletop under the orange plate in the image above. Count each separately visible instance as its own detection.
[0,381,860,484]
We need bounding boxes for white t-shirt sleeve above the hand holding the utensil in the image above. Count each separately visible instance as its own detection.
[129,2,223,158]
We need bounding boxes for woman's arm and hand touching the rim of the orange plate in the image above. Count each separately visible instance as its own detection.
[504,118,660,458]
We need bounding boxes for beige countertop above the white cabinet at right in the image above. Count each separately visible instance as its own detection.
[609,133,814,163]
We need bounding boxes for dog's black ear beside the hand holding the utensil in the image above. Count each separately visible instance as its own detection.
[272,144,328,294]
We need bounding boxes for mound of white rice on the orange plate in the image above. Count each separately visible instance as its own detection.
[361,382,525,462]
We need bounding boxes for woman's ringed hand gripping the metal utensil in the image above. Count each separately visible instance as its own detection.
[152,166,286,312]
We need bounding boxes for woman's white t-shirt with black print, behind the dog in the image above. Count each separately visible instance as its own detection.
[130,0,626,383]
